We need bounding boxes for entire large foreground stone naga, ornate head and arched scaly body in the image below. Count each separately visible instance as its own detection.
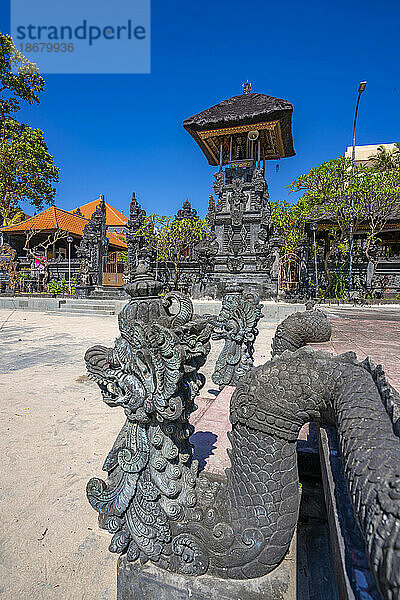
[85,278,400,600]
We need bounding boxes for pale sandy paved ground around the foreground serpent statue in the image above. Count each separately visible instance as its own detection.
[0,308,400,600]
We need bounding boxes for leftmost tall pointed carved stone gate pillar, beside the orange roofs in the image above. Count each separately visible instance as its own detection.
[77,196,108,285]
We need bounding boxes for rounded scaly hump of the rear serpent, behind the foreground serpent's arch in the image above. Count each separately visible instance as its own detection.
[271,302,332,356]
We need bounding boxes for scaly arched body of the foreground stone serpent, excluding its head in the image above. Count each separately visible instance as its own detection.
[180,349,400,600]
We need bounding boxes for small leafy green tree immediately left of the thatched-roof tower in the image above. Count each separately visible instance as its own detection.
[135,214,210,289]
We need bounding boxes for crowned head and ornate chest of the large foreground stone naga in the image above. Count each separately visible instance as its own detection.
[85,262,213,571]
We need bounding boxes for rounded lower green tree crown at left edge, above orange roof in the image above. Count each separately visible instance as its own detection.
[0,119,59,225]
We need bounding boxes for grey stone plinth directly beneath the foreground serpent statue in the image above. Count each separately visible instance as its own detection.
[117,535,296,600]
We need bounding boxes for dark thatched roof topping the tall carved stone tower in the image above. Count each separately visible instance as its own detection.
[183,93,295,164]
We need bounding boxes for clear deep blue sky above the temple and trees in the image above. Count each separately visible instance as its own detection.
[0,0,400,215]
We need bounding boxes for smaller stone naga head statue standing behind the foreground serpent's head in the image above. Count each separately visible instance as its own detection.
[212,287,262,389]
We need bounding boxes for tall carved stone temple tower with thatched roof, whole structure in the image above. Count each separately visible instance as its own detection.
[183,82,295,298]
